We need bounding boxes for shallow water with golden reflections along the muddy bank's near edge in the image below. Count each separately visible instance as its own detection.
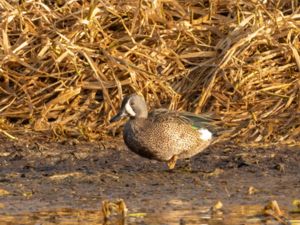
[0,205,300,225]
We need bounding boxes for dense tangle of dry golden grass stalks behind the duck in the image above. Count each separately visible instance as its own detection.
[0,0,300,143]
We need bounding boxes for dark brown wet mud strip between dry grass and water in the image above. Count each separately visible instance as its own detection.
[0,133,300,223]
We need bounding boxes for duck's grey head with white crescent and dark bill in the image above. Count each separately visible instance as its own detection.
[110,94,148,122]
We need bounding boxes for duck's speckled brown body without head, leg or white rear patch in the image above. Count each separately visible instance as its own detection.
[124,110,210,161]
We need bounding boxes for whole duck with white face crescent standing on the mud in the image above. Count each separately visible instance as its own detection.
[110,94,213,169]
